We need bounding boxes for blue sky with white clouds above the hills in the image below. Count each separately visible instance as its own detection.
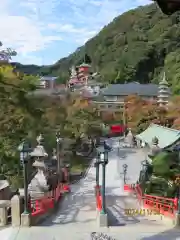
[0,0,150,65]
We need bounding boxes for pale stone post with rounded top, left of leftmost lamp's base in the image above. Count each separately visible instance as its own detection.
[11,195,21,227]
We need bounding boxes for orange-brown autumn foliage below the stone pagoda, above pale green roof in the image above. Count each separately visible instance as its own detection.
[125,95,177,133]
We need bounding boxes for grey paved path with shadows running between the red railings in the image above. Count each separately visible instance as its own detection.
[7,138,180,240]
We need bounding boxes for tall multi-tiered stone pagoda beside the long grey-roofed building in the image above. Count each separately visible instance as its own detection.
[157,73,170,106]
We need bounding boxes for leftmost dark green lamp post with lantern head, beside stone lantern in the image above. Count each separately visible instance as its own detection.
[18,141,31,214]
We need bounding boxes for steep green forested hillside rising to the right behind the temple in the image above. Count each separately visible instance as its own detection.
[13,4,180,93]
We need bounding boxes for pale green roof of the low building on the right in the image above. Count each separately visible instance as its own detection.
[136,124,180,148]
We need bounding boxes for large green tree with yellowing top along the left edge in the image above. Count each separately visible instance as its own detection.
[0,64,41,188]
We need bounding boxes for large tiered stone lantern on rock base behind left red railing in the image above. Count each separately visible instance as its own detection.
[28,135,49,200]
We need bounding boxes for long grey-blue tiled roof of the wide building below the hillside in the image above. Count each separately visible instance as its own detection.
[103,83,158,96]
